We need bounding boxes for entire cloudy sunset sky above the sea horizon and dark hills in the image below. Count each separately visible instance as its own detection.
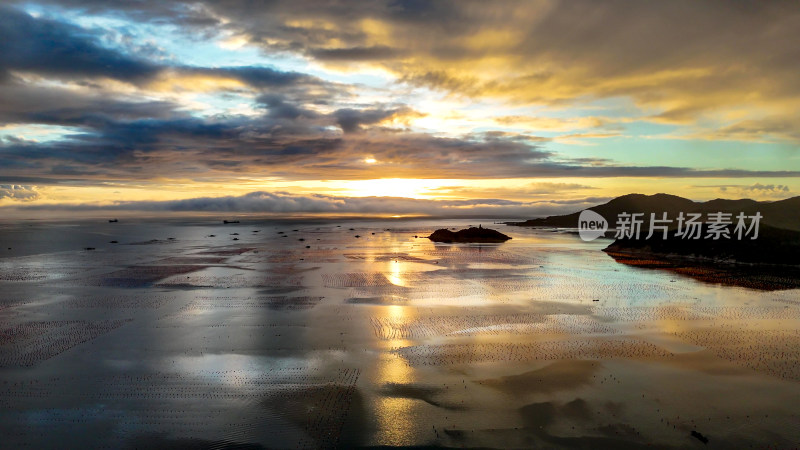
[0,0,800,218]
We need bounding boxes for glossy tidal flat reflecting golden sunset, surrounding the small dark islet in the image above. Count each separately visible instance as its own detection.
[0,218,800,449]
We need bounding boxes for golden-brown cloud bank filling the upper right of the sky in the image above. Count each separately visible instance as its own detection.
[17,0,800,137]
